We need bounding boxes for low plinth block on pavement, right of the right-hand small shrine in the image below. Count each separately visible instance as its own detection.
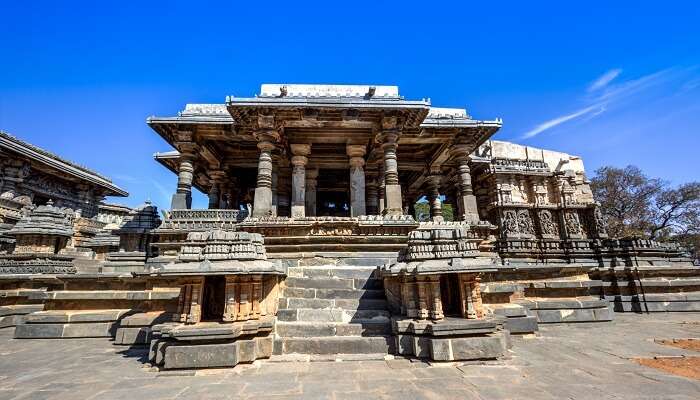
[517,297,614,324]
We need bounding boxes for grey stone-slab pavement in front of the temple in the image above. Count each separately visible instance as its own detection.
[0,313,700,400]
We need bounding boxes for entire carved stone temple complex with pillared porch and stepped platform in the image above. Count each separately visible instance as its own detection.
[0,84,700,369]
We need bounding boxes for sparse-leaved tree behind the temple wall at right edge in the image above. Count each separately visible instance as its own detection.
[591,165,700,240]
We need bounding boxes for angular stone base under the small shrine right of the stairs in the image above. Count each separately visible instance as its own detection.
[393,318,510,361]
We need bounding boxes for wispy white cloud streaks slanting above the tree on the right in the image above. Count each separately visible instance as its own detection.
[521,68,693,139]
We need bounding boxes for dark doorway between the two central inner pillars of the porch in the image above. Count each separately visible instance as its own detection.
[316,169,350,217]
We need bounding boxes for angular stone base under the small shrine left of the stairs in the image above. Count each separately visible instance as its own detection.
[149,317,274,369]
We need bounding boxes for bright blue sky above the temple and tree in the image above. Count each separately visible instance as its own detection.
[0,0,700,208]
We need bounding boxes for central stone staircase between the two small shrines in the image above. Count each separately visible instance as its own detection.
[274,266,394,360]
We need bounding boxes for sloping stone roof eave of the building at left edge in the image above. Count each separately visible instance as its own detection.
[0,131,129,197]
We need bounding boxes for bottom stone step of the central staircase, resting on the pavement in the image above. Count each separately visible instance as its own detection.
[273,336,395,355]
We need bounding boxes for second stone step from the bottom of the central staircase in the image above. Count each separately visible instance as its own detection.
[275,320,391,338]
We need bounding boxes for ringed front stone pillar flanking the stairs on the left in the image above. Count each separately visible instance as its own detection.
[253,129,279,218]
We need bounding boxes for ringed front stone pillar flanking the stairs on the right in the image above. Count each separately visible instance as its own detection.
[379,117,403,215]
